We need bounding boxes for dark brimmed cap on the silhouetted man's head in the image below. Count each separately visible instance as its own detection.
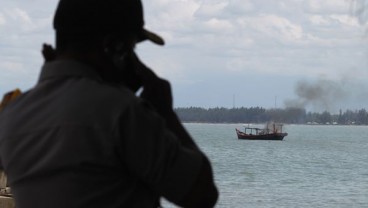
[54,0,164,45]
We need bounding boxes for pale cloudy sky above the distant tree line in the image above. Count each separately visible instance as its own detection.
[0,0,368,112]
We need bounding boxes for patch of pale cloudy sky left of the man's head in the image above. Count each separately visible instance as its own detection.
[0,0,55,96]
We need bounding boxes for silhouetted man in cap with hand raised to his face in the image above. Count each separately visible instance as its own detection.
[0,0,218,208]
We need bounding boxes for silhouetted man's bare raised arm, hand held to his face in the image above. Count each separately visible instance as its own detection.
[137,62,218,208]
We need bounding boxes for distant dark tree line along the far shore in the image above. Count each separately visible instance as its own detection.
[175,107,368,125]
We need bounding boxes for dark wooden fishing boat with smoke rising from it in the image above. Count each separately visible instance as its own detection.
[235,122,288,140]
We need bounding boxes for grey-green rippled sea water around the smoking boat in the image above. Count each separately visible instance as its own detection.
[162,123,368,208]
